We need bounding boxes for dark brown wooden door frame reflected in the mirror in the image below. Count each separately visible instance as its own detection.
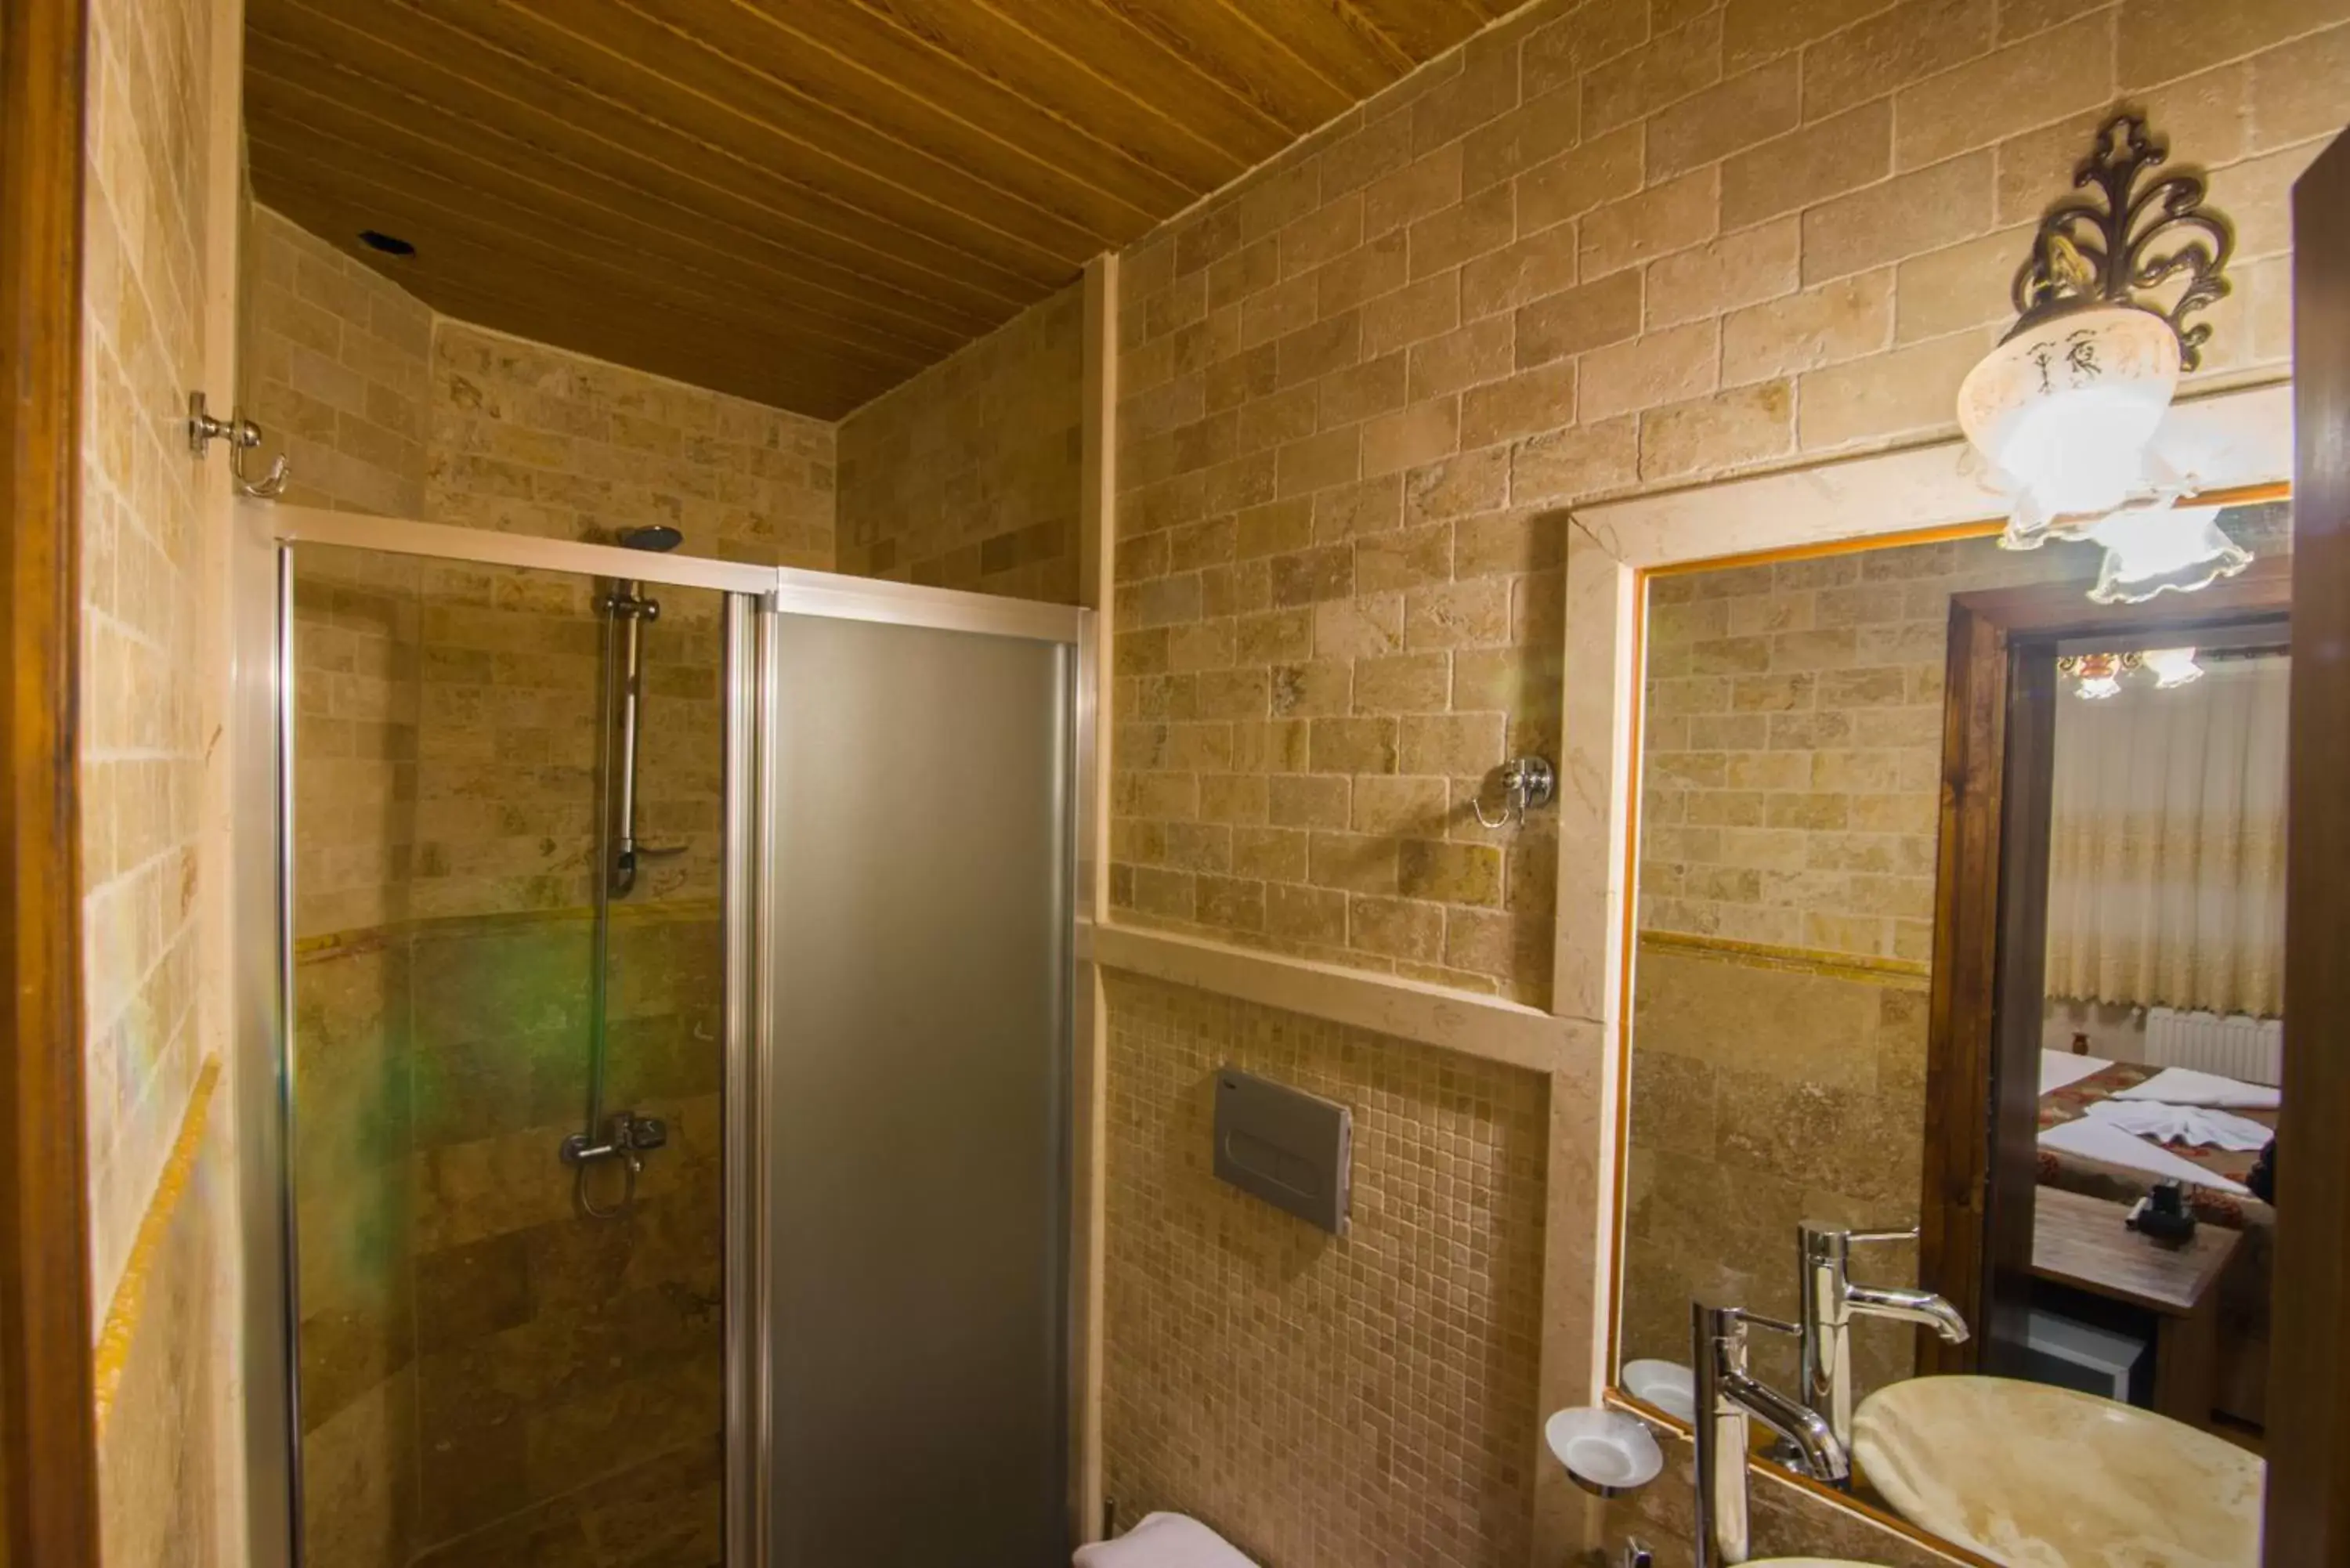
[1918,557,2294,1375]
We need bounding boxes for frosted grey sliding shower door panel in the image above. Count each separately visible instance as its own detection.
[764,616,1069,1568]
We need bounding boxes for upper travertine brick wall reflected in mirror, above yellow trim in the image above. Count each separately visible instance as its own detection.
[1640,538,2096,962]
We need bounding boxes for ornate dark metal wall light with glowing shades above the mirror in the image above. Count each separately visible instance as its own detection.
[1958,110,2251,602]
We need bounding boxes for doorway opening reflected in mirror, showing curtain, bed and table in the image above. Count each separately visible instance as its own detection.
[2016,623,2289,1446]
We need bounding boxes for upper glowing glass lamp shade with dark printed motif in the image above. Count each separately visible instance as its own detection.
[1958,305,2178,550]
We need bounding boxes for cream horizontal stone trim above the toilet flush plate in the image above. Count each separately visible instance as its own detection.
[1081,927,1577,1072]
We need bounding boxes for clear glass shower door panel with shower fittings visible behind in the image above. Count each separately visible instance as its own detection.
[287,545,728,1568]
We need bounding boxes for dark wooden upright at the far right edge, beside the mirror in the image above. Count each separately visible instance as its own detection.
[2263,136,2350,1568]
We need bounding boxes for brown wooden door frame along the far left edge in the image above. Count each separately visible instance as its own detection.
[0,0,99,1568]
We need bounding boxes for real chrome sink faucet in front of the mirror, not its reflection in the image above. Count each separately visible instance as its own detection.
[1690,1300,1852,1568]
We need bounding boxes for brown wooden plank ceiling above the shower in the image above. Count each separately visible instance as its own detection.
[244,0,1518,418]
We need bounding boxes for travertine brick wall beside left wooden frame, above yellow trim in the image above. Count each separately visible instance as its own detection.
[80,0,221,1314]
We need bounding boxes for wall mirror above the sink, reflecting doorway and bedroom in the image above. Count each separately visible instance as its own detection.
[1614,500,2291,1563]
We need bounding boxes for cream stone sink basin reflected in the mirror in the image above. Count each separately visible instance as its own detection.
[1852,1378,2268,1568]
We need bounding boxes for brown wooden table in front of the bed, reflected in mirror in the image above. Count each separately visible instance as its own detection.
[2033,1187,2244,1427]
